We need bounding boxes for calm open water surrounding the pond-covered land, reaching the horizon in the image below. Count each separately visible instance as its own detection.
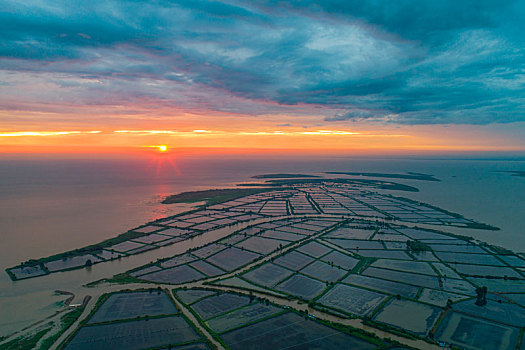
[0,156,525,335]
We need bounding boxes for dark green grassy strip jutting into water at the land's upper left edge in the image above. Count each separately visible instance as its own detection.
[162,188,280,205]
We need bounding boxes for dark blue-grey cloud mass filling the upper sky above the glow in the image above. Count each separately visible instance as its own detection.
[0,0,525,124]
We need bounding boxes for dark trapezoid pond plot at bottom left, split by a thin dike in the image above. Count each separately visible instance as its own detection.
[64,290,205,350]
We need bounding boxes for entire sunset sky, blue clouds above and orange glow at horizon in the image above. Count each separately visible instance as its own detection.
[0,0,525,152]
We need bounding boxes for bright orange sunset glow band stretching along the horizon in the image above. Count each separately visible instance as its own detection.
[0,124,525,157]
